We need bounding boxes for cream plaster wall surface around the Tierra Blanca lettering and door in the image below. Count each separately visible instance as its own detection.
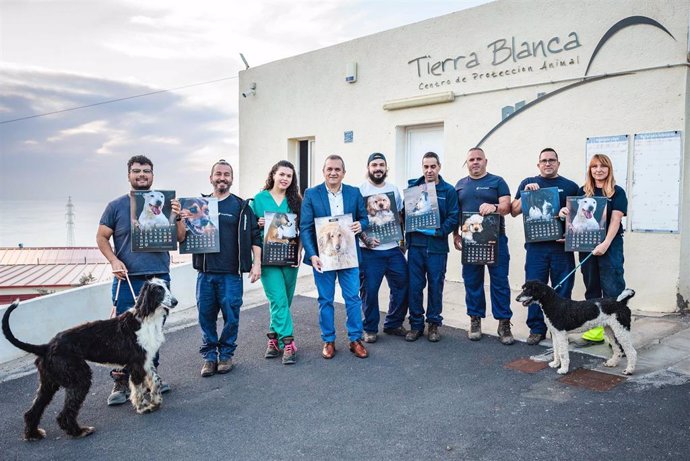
[239,0,690,312]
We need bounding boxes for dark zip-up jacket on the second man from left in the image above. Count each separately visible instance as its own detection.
[192,194,262,273]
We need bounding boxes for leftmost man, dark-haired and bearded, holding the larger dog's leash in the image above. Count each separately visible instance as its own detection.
[96,155,184,405]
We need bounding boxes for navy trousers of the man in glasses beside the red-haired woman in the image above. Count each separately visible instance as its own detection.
[525,242,575,334]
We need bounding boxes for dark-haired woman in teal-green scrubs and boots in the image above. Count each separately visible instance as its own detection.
[252,160,302,365]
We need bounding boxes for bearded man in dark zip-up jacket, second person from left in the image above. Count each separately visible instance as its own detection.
[177,160,261,378]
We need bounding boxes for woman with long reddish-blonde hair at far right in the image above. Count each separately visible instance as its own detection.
[564,154,628,343]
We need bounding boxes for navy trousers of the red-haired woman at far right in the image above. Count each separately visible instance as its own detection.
[580,236,625,299]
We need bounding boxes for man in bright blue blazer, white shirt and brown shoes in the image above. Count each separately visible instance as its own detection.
[299,155,369,359]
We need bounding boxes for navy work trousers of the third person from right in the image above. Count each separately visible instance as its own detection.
[462,235,513,320]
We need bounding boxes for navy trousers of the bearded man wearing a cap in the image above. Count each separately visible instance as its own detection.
[359,247,407,333]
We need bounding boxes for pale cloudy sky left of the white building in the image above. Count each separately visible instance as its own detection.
[0,0,487,206]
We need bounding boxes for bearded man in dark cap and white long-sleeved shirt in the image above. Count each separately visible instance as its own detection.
[359,152,408,343]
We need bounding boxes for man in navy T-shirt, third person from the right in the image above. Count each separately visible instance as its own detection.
[453,147,514,345]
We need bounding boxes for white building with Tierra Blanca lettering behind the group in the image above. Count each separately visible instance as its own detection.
[240,0,690,312]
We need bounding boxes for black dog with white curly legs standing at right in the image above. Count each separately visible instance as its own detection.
[515,280,637,375]
